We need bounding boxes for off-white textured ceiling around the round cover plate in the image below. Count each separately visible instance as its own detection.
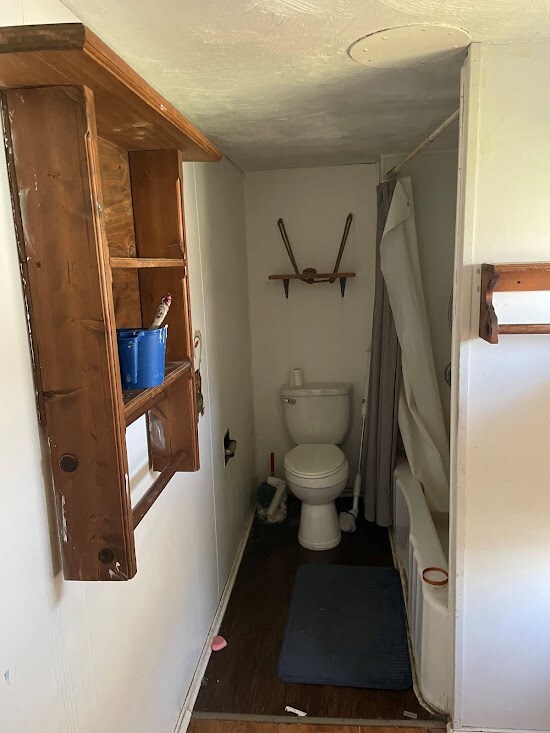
[65,0,550,170]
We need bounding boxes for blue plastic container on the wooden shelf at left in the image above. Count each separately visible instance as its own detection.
[117,326,168,389]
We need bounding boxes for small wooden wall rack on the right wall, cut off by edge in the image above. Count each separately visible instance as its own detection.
[479,262,550,344]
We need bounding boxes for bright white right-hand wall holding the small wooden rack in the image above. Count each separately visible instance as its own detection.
[451,42,550,730]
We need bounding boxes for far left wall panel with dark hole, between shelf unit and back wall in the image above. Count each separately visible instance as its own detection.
[184,161,255,593]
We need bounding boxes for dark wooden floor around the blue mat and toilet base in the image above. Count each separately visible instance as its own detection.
[195,498,442,720]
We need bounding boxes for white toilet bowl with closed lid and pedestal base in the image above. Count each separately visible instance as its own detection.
[284,443,349,550]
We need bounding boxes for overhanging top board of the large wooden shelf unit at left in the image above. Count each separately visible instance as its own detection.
[0,23,221,161]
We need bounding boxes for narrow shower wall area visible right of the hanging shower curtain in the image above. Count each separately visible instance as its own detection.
[381,151,458,433]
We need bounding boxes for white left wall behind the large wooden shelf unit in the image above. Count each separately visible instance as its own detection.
[0,0,254,733]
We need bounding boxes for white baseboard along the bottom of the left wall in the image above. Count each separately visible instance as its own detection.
[174,507,256,733]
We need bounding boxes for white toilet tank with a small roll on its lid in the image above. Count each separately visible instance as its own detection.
[281,382,351,445]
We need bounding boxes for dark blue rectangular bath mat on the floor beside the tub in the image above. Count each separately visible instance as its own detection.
[278,565,412,690]
